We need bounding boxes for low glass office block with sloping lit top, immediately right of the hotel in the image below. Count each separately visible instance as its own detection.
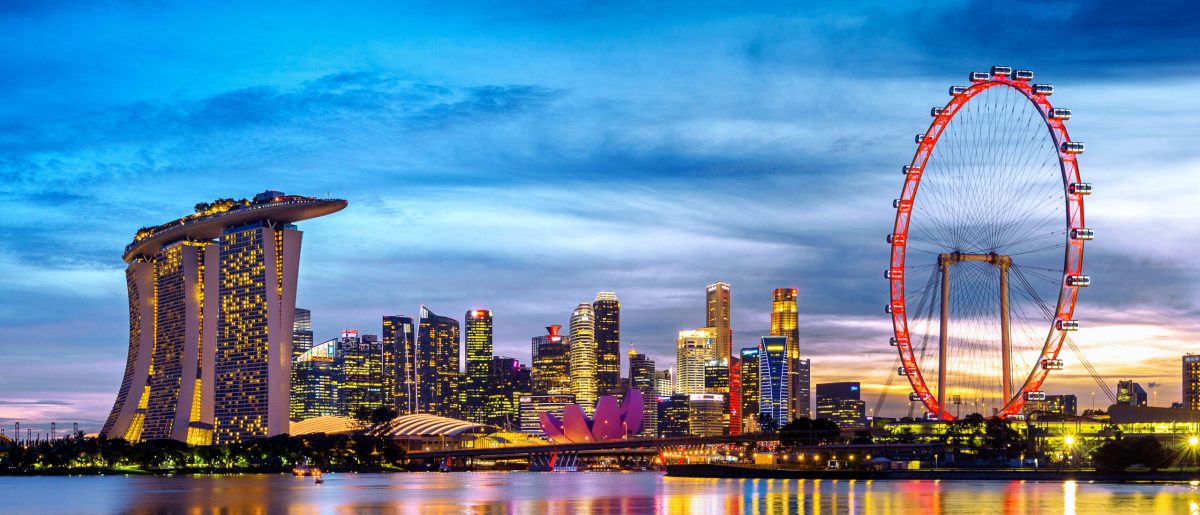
[292,339,341,421]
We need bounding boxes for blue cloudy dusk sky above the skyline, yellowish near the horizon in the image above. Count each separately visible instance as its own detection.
[0,0,1200,431]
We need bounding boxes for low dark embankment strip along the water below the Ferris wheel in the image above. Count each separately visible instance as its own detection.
[666,463,1200,484]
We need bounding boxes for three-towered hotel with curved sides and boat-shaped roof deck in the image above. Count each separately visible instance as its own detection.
[103,191,346,444]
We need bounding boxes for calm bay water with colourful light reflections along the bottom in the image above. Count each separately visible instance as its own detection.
[0,472,1200,515]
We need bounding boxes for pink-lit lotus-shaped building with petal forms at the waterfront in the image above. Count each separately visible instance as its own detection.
[538,389,643,443]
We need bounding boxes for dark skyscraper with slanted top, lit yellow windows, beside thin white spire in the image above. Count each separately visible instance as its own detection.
[416,306,460,418]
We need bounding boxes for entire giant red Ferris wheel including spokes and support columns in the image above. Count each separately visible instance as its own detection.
[886,66,1093,420]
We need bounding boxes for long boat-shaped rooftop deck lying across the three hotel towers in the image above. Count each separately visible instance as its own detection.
[122,196,346,263]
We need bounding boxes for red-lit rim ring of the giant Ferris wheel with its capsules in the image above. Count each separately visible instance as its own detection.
[887,67,1088,420]
